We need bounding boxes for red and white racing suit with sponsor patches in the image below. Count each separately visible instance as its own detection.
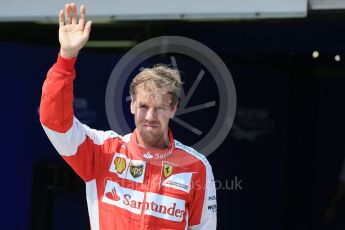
[40,55,217,230]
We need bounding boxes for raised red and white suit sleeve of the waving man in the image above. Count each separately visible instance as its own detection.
[40,55,118,181]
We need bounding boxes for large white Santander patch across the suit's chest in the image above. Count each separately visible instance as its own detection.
[102,180,186,222]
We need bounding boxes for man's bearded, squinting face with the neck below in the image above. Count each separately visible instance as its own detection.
[131,85,177,148]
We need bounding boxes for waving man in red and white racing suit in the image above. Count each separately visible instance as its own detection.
[40,3,217,230]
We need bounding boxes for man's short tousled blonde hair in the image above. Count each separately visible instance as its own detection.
[129,64,182,107]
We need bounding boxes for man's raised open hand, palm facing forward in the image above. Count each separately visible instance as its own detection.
[59,3,91,58]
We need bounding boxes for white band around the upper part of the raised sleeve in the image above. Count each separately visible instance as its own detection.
[42,117,121,156]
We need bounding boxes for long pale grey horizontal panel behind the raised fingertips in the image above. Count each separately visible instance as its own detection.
[0,0,307,21]
